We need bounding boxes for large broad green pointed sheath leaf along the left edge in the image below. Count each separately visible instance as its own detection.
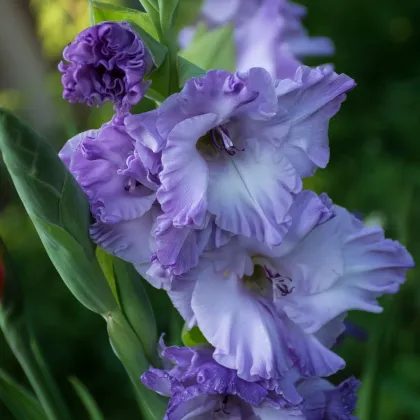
[0,110,117,314]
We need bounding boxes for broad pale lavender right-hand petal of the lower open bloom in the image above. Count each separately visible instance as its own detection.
[279,206,413,333]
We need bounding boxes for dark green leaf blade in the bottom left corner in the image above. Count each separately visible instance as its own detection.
[0,369,48,420]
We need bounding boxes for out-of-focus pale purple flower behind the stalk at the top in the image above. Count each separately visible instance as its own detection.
[180,0,334,78]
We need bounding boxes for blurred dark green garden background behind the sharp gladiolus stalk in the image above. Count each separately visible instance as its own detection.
[0,0,420,420]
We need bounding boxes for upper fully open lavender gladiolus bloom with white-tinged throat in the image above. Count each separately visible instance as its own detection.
[125,67,354,273]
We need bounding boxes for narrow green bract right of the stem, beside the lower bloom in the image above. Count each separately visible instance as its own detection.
[113,258,158,363]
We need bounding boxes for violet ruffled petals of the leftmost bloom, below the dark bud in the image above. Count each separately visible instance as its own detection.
[59,117,156,223]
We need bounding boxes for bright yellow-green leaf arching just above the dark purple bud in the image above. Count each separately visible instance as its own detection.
[89,0,158,39]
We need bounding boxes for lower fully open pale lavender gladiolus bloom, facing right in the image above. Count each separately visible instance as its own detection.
[169,191,413,380]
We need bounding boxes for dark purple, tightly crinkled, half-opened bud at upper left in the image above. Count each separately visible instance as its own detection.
[58,22,153,112]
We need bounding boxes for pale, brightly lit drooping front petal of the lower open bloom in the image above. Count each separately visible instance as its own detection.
[192,266,289,381]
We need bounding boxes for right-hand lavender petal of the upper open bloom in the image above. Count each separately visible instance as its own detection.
[278,66,355,177]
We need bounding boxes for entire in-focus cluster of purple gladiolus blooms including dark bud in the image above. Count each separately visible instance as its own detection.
[60,4,413,420]
